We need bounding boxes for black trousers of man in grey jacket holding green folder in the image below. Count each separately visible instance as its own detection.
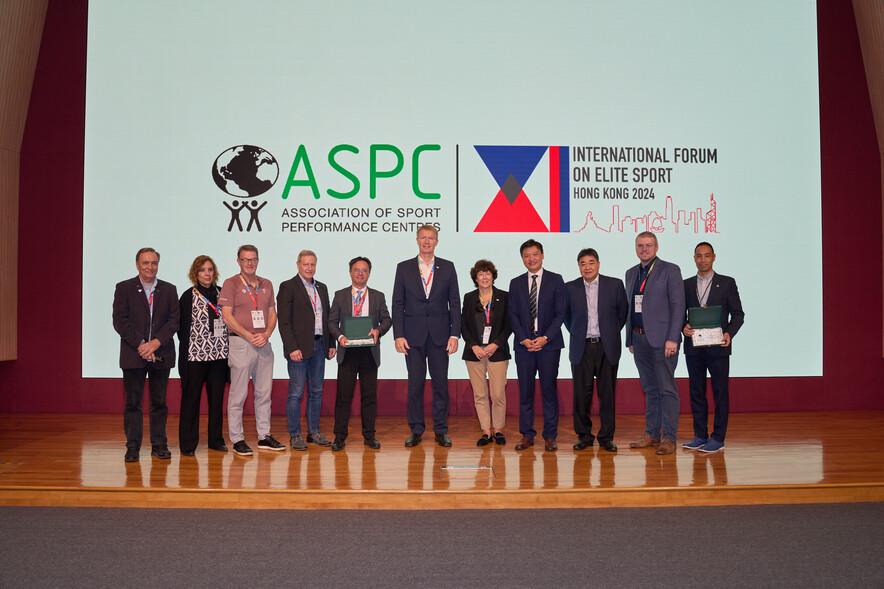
[335,348,378,440]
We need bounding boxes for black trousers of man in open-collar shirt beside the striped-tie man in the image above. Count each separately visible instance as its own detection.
[571,340,617,443]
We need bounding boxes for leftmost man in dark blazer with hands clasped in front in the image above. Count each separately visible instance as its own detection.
[113,247,180,462]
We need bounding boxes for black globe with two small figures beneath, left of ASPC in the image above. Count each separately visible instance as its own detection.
[212,145,279,231]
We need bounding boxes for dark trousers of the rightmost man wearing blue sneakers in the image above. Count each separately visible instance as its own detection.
[685,348,731,442]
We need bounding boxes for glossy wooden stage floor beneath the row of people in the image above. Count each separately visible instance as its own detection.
[0,411,884,509]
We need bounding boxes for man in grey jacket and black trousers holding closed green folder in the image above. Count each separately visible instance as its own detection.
[328,257,393,452]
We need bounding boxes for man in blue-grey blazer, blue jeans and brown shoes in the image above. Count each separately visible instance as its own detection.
[626,231,685,455]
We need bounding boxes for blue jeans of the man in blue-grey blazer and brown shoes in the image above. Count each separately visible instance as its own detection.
[632,333,679,441]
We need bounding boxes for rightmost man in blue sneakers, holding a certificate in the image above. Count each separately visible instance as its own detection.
[682,241,744,453]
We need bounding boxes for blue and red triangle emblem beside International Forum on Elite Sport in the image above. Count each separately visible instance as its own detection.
[473,145,571,233]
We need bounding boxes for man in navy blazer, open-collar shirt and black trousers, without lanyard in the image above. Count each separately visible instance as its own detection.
[565,248,629,452]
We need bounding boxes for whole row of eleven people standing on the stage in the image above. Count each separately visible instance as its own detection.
[113,225,743,462]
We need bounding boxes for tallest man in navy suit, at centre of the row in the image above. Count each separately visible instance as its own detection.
[393,225,460,448]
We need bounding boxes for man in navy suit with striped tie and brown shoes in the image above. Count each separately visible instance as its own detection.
[509,239,566,452]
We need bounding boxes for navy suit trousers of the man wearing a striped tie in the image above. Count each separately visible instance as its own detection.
[516,350,562,440]
